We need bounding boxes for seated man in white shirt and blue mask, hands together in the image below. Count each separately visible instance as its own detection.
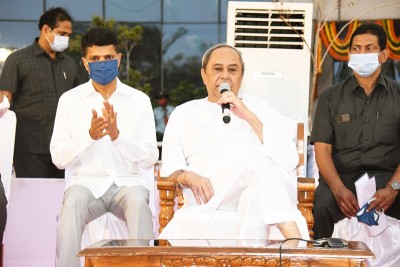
[50,28,158,267]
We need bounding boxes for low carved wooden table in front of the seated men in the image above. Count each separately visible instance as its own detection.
[79,239,374,267]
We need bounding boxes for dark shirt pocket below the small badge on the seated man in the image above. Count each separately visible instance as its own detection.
[334,121,359,149]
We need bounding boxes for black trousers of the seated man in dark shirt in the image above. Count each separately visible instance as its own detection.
[313,172,400,239]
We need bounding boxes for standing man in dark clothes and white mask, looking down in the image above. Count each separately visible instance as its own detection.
[0,7,81,178]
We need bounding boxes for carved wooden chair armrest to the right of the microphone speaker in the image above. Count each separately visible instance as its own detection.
[297,177,315,239]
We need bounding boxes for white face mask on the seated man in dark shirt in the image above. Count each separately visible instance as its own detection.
[349,53,381,77]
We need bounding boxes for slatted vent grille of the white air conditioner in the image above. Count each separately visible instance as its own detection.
[234,9,306,49]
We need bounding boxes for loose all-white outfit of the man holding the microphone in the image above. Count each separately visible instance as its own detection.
[160,96,305,239]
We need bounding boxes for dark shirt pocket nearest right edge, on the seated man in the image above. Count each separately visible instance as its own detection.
[375,116,400,145]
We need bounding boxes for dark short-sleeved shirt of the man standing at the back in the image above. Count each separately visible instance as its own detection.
[0,38,81,153]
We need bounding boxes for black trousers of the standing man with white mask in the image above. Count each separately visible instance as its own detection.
[14,153,64,178]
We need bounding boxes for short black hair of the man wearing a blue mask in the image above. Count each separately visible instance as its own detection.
[81,28,118,56]
